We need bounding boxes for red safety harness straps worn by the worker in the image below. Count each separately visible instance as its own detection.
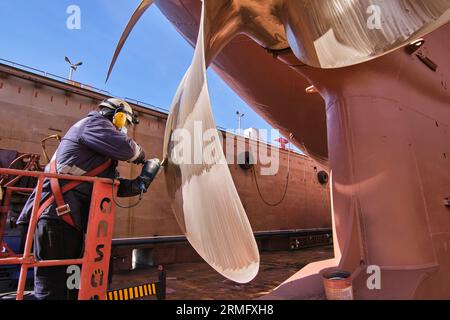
[37,160,112,231]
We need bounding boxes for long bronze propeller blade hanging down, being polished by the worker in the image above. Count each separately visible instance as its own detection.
[164,1,260,283]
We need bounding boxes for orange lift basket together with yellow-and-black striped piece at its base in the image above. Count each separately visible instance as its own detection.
[0,164,165,300]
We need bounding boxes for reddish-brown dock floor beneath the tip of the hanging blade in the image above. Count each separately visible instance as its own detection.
[110,246,333,300]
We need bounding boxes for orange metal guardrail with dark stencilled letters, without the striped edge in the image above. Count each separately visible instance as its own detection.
[0,169,117,300]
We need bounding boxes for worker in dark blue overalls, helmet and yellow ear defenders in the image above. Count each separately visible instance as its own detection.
[17,98,160,300]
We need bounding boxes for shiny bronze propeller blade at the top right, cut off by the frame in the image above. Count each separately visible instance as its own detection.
[283,0,450,68]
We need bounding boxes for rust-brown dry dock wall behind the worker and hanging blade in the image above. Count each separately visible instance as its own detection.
[0,64,331,238]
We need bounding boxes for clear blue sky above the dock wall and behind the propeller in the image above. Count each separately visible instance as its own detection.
[0,0,282,142]
